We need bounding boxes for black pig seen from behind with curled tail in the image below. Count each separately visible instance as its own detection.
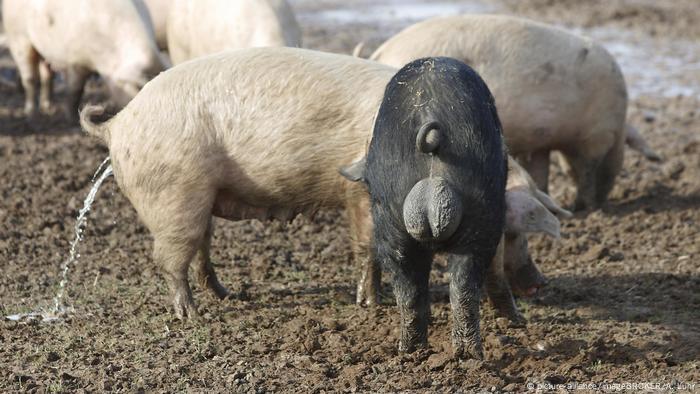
[344,57,508,358]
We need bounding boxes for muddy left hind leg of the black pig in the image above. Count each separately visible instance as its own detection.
[375,231,432,352]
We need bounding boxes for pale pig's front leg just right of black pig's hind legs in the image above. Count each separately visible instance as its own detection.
[484,237,525,326]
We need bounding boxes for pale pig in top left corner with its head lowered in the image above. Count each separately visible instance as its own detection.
[2,0,167,119]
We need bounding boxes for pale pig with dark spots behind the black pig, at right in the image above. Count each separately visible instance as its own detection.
[370,15,658,209]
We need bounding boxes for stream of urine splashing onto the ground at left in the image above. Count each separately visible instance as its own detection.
[5,157,112,322]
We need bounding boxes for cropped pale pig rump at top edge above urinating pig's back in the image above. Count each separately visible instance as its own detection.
[170,0,301,64]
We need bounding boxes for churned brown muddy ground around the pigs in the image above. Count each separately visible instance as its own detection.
[0,0,700,392]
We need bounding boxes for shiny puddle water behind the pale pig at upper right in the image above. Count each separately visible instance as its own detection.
[291,0,700,99]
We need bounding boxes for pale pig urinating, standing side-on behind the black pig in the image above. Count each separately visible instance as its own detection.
[81,48,558,324]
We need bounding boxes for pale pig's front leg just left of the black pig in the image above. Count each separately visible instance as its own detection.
[346,198,381,306]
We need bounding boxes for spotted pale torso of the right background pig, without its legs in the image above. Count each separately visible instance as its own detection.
[371,15,627,154]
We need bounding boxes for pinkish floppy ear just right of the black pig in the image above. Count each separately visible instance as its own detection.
[506,190,561,239]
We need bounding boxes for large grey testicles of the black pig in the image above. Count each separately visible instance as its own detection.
[403,177,462,242]
